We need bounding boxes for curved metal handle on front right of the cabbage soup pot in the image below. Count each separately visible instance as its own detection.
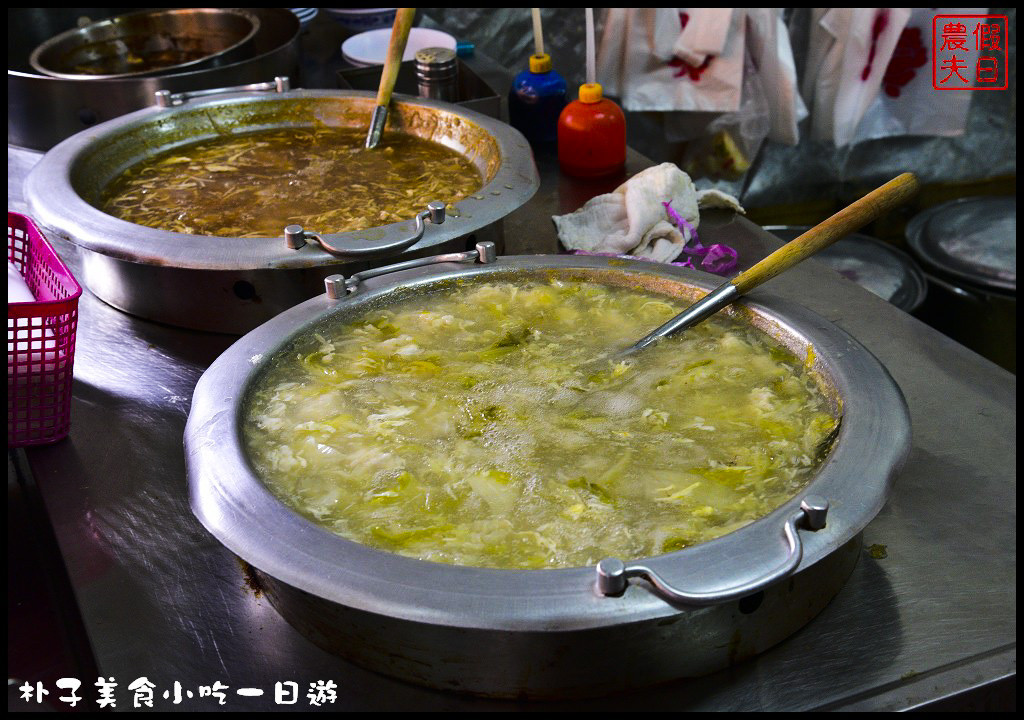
[597,495,828,606]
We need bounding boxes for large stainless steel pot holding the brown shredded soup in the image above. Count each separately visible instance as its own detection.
[26,90,540,333]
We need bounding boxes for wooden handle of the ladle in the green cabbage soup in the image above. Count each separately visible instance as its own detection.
[730,172,918,294]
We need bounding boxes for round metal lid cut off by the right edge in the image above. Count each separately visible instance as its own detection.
[906,196,1017,293]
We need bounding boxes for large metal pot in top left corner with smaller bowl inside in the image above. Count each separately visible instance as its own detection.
[7,7,300,151]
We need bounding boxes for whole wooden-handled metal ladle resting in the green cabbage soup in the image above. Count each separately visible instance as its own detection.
[611,172,918,359]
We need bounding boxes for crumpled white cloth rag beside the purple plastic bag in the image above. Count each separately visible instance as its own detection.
[551,163,742,262]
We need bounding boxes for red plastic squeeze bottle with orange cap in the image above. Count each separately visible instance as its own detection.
[558,83,626,177]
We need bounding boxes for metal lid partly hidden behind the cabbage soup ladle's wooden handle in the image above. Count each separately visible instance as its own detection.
[765,225,928,312]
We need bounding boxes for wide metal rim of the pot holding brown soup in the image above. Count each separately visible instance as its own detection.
[25,90,540,270]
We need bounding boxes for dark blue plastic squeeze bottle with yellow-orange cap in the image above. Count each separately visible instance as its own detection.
[509,53,567,147]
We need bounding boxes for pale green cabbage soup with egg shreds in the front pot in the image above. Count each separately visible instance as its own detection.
[245,280,838,567]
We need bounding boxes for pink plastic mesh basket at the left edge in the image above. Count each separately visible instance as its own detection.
[7,212,82,448]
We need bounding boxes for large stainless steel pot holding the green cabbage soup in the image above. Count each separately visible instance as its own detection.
[185,253,910,697]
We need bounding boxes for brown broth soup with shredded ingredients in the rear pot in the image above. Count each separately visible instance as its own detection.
[100,127,483,238]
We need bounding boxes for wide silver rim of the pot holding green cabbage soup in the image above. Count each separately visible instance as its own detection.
[184,255,910,632]
